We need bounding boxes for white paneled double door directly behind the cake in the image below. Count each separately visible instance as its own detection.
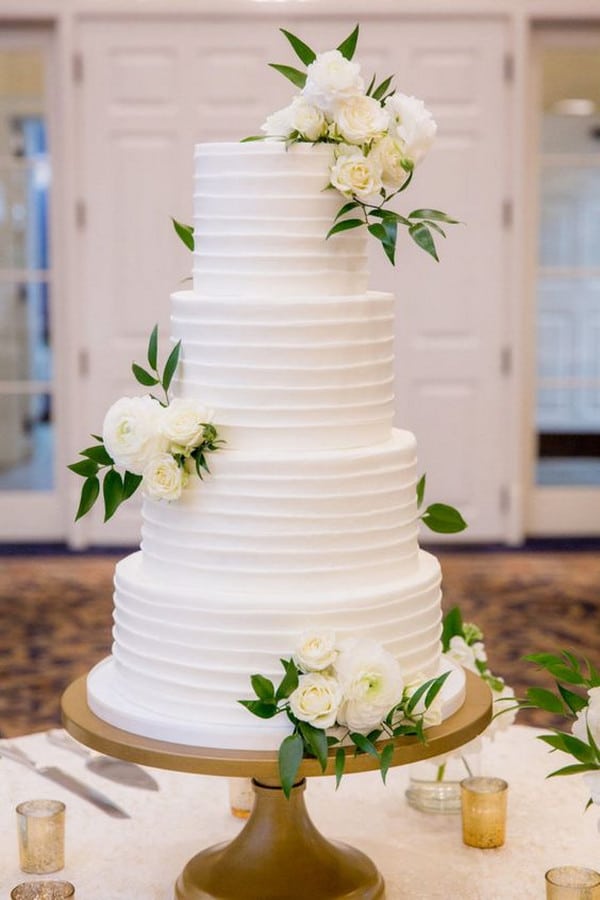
[71,14,516,544]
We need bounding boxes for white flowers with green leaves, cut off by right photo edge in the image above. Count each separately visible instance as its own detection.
[519,650,600,812]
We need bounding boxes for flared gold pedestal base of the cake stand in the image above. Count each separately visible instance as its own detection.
[175,779,384,900]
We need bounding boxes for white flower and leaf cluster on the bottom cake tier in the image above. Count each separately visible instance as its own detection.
[239,630,449,796]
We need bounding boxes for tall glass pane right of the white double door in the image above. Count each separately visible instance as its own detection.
[536,40,600,486]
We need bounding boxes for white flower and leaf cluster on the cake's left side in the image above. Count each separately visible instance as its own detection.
[69,327,224,521]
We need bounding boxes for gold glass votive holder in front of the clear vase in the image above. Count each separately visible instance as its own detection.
[460,776,508,850]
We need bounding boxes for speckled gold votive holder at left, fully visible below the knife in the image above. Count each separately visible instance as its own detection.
[17,800,65,875]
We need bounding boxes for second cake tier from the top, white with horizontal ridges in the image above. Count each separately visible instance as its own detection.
[171,291,394,451]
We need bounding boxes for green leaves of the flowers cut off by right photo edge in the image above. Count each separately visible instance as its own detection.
[519,650,600,792]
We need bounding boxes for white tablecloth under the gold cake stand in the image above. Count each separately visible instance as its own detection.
[0,725,600,900]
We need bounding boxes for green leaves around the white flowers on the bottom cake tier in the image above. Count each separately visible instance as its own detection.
[238,659,449,797]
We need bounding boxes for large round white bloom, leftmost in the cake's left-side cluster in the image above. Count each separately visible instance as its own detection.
[102,396,167,475]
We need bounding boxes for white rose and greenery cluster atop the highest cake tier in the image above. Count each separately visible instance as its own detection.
[246,25,456,263]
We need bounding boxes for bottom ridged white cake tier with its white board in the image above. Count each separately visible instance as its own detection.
[88,551,464,750]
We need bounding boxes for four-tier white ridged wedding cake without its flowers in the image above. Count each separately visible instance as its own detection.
[88,141,463,749]
